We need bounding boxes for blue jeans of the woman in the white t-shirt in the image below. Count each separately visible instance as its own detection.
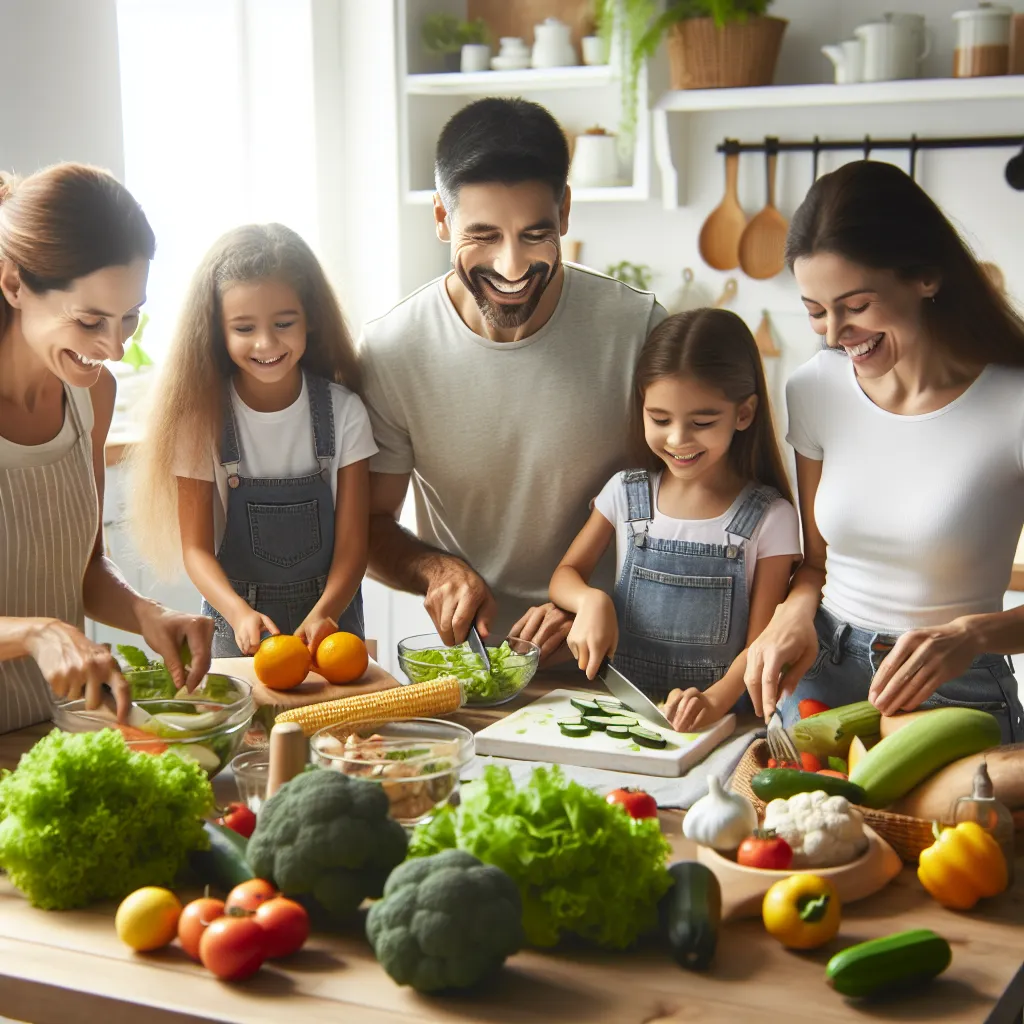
[779,607,1024,743]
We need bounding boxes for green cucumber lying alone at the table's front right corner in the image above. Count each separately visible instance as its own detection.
[825,925,953,998]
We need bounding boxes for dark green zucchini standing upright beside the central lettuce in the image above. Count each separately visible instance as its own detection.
[658,860,722,971]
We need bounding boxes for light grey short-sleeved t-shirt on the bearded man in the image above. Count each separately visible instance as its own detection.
[360,264,666,636]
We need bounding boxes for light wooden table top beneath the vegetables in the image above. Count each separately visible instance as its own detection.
[0,674,1024,1024]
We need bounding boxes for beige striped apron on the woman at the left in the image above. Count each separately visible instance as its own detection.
[0,385,99,732]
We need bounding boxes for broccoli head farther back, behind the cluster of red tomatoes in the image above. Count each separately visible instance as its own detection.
[247,768,408,919]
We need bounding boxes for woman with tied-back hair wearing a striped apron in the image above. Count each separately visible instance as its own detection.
[0,164,213,732]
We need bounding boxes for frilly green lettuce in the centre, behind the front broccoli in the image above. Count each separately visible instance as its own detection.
[410,765,672,949]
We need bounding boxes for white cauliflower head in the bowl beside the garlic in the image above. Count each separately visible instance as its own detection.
[764,790,867,867]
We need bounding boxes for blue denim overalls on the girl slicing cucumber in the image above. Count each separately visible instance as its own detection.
[613,469,779,710]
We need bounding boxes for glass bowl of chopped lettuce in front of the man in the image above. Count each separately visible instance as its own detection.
[398,633,541,708]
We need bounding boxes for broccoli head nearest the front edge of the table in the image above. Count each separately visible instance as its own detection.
[367,850,523,992]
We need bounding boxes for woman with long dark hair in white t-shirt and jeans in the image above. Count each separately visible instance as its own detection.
[745,161,1024,742]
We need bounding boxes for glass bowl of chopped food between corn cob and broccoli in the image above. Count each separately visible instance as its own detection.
[309,718,475,827]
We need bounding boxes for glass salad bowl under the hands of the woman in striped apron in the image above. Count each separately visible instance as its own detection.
[53,674,256,778]
